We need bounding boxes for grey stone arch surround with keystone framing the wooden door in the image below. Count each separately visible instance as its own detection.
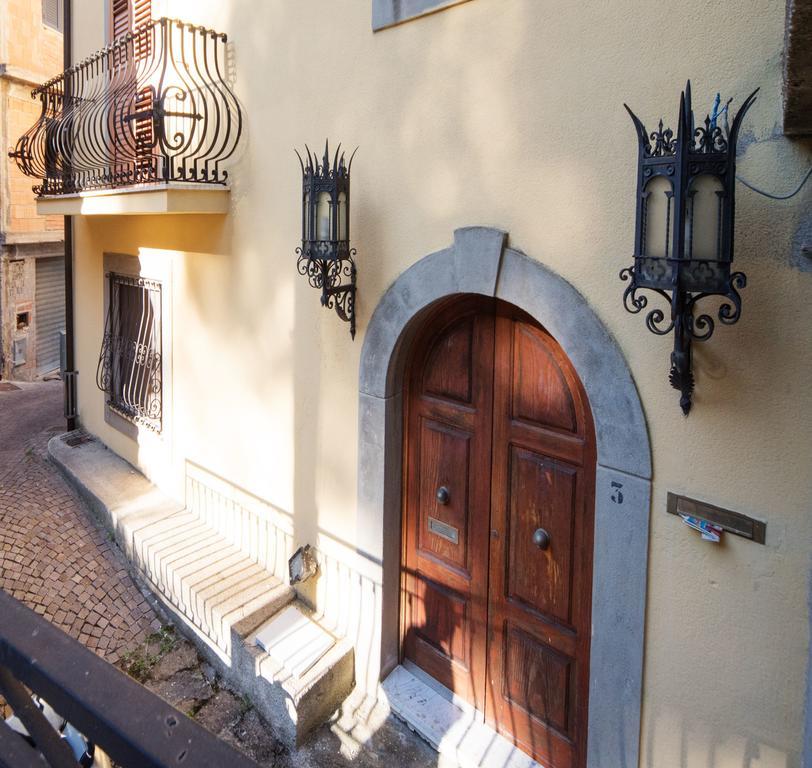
[357,227,651,768]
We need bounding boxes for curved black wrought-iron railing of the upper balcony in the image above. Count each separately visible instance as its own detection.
[9,18,242,196]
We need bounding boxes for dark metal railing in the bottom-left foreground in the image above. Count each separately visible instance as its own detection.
[0,591,256,768]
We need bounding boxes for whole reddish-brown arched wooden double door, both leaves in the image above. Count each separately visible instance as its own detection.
[401,296,595,768]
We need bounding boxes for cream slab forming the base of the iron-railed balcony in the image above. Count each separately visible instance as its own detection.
[37,187,230,216]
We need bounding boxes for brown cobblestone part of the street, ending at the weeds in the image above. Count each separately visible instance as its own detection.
[0,381,161,663]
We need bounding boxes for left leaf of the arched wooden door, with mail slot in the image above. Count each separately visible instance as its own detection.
[402,300,494,709]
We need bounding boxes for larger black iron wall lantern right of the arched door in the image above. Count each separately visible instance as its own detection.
[620,81,758,415]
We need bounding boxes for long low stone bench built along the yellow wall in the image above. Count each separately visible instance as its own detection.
[48,431,354,746]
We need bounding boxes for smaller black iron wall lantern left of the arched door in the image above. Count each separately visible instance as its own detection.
[296,143,357,339]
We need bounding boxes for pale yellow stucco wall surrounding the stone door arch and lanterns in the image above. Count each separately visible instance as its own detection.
[65,0,812,768]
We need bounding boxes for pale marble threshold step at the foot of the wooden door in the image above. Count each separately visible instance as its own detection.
[383,665,544,768]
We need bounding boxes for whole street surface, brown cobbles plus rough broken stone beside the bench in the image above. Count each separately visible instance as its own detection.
[0,381,438,768]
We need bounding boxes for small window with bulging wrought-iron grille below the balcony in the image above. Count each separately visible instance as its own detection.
[96,272,163,432]
